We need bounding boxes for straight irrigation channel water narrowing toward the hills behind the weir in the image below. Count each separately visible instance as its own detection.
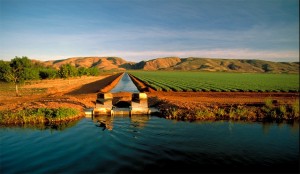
[110,73,139,92]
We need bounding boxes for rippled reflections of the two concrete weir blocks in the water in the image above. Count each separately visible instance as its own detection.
[92,115,150,131]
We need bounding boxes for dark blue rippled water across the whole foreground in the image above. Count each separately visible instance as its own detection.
[0,116,299,173]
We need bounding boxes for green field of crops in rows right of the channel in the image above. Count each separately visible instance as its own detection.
[129,71,299,92]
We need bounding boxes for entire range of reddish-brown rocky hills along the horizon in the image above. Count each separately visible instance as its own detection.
[41,57,299,73]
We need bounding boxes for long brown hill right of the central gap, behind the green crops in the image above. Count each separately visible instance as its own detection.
[127,57,299,73]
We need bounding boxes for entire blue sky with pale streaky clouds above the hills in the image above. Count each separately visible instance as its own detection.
[0,0,299,62]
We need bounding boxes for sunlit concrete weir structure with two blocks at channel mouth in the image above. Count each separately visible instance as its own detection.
[93,93,158,116]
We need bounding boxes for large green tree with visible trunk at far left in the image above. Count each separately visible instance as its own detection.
[0,57,38,96]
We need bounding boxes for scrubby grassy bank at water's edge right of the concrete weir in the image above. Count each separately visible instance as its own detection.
[159,100,299,122]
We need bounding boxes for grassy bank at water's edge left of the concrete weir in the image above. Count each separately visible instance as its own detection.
[0,108,80,125]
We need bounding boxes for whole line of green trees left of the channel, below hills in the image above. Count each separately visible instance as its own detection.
[0,56,100,96]
